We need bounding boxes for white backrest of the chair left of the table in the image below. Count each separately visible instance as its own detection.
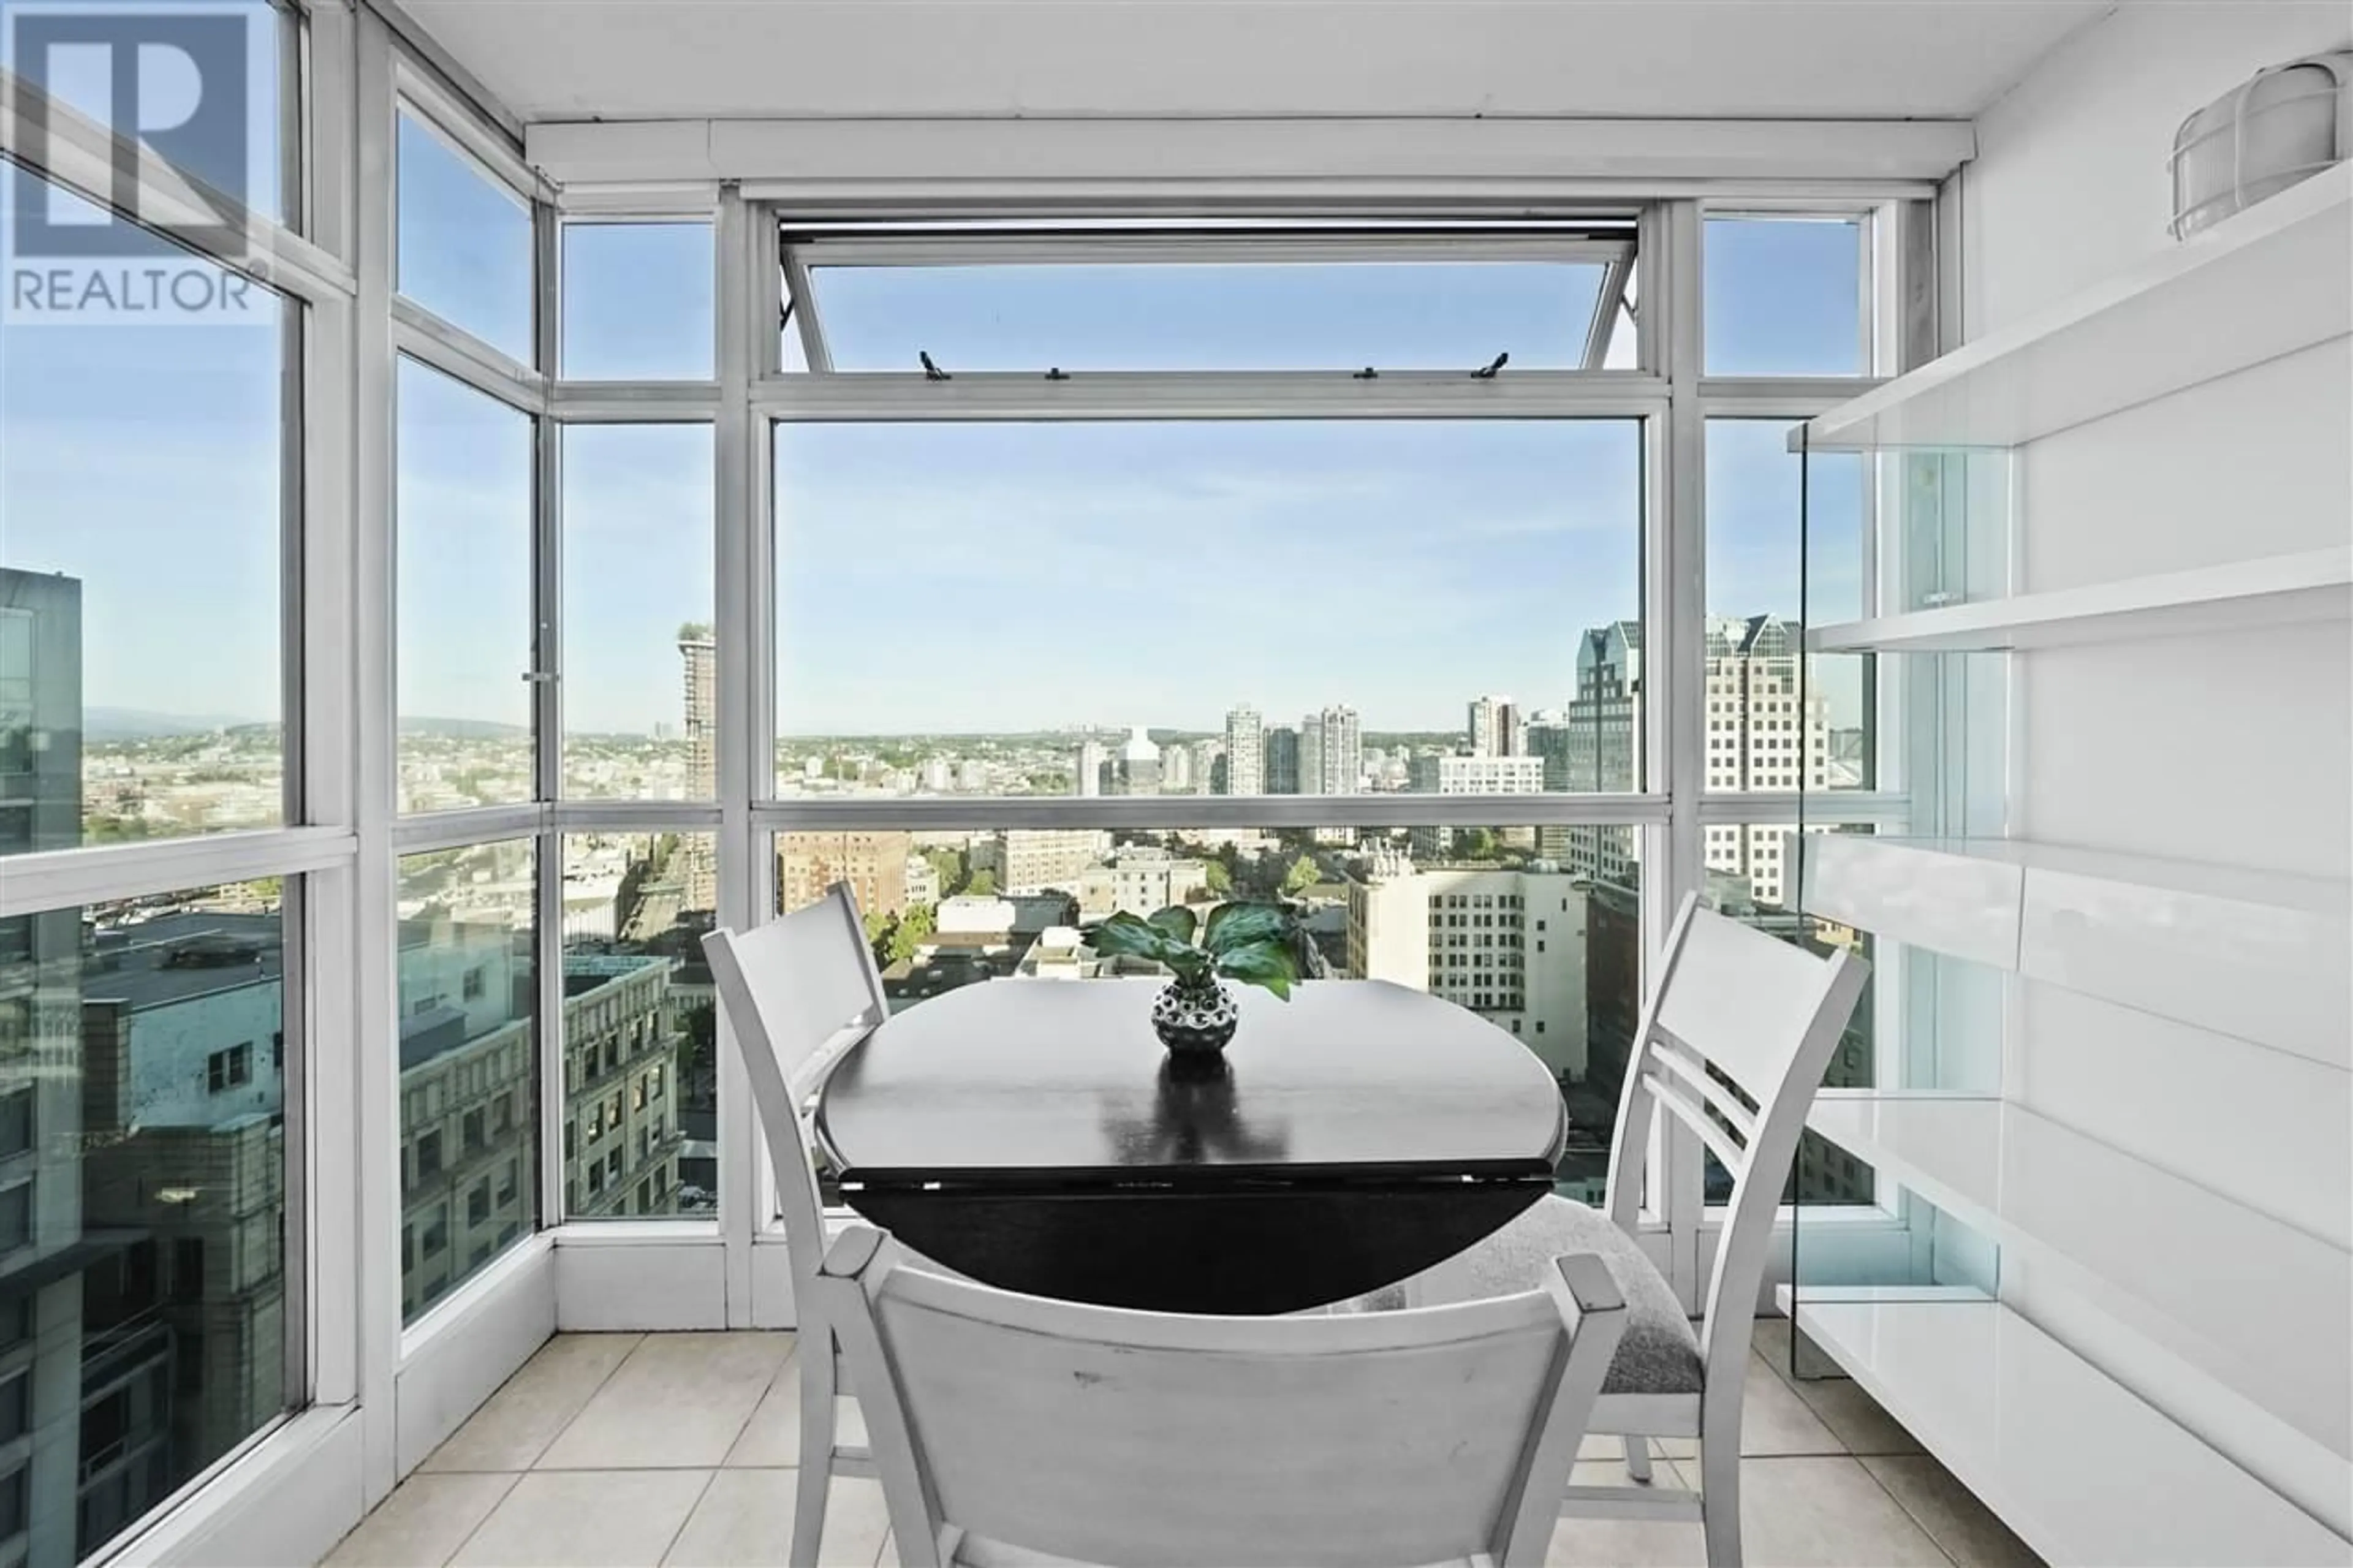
[703,883,890,1300]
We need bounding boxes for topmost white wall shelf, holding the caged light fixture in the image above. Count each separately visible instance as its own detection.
[1790,165,2353,452]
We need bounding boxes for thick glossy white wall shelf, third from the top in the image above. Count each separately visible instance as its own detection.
[1798,833,2353,1071]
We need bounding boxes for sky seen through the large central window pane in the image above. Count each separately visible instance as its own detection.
[776,422,1642,732]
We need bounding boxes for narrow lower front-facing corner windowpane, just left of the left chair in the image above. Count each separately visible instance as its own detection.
[563,833,718,1219]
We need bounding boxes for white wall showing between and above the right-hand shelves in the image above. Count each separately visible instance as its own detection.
[1960,0,2353,1532]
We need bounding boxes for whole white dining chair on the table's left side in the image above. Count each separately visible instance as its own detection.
[703,883,890,1568]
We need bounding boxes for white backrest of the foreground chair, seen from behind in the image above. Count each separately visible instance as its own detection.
[816,1227,1626,1568]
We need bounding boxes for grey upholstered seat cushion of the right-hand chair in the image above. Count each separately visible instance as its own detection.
[1351,1199,1701,1394]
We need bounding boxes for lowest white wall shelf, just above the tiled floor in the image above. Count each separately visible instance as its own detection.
[1781,1286,2353,1568]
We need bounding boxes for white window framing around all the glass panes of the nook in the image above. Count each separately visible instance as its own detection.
[0,12,1936,1559]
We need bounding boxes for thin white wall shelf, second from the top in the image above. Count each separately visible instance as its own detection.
[1805,546,2353,652]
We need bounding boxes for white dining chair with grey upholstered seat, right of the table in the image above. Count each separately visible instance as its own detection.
[1351,897,1871,1568]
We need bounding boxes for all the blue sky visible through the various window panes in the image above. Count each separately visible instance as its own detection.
[0,127,1859,735]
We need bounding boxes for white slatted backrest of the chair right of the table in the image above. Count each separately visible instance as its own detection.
[1610,895,1871,1392]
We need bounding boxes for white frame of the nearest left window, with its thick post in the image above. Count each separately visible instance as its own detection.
[0,2,360,1559]
